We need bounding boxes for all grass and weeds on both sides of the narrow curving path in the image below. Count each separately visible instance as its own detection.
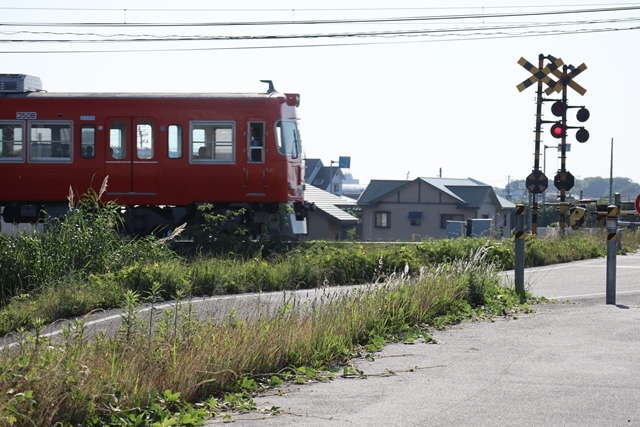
[0,183,640,426]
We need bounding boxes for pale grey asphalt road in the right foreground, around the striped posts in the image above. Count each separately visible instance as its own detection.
[207,254,640,427]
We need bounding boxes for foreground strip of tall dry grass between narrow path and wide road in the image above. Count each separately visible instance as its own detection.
[0,246,526,425]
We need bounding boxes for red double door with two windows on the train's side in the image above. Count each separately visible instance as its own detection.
[105,117,158,196]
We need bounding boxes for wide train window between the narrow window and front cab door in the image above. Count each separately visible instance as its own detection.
[190,122,235,163]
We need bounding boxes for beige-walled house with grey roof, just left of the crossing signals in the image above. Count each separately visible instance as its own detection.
[358,178,515,241]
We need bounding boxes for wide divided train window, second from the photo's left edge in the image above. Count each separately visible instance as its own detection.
[28,121,72,162]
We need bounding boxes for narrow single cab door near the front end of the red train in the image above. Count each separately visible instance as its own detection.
[245,122,267,197]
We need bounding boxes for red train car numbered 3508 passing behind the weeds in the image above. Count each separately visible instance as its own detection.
[0,74,308,234]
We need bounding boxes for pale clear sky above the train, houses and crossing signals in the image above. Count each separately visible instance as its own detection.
[0,0,640,188]
